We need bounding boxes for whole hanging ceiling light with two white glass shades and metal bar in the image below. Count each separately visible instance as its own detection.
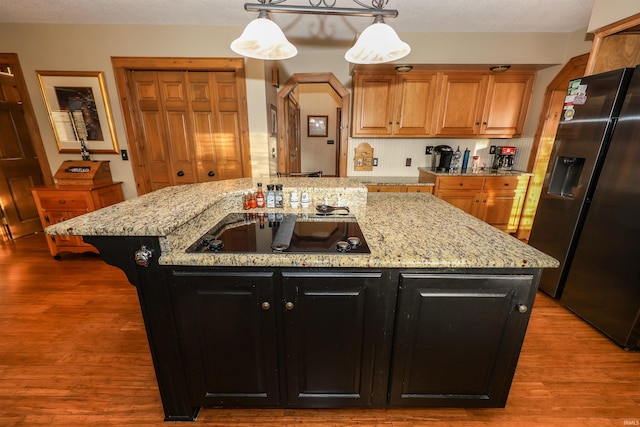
[231,0,411,64]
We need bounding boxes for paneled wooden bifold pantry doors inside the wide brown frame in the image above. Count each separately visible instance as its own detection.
[114,58,251,195]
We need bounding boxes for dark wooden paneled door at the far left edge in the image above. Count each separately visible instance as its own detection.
[0,74,43,238]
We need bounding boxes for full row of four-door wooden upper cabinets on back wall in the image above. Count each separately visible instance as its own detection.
[351,71,535,138]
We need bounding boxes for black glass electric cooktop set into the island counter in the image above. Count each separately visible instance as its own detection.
[187,212,371,254]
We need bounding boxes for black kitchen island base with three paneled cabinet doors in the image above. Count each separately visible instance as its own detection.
[85,237,540,421]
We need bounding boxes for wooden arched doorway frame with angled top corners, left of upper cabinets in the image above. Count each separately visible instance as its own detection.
[278,73,351,177]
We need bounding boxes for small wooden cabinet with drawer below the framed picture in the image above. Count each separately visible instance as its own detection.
[31,182,124,259]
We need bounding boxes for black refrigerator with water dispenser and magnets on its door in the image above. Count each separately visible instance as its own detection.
[529,67,640,348]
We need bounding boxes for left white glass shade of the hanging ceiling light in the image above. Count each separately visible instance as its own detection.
[231,12,298,60]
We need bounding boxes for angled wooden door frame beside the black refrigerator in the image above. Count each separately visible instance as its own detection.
[516,53,589,240]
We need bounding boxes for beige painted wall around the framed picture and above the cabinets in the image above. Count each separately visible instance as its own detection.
[0,24,596,198]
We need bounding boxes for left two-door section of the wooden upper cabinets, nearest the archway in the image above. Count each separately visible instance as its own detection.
[351,72,438,137]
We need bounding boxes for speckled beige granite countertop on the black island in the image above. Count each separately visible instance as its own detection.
[46,178,558,268]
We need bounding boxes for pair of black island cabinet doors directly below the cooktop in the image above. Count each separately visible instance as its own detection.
[173,271,385,407]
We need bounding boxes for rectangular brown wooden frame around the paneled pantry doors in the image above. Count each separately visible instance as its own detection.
[111,56,251,195]
